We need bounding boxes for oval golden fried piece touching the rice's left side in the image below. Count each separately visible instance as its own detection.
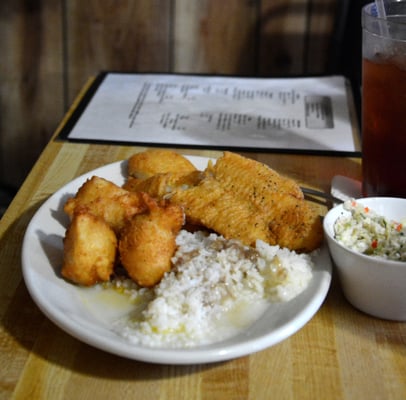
[118,193,184,287]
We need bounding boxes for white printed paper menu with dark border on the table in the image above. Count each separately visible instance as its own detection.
[64,73,359,152]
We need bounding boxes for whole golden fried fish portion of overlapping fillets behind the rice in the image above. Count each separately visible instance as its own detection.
[169,153,323,252]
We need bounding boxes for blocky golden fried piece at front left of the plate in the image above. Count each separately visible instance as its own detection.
[61,212,117,286]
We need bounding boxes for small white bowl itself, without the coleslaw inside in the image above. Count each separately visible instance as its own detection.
[323,197,406,321]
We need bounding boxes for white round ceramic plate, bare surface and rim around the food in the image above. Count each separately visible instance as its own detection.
[22,157,331,364]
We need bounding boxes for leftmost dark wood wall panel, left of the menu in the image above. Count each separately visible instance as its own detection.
[0,0,63,187]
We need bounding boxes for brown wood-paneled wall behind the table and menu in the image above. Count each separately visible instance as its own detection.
[0,0,341,194]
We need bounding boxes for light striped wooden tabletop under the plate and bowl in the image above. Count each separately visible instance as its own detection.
[0,94,406,400]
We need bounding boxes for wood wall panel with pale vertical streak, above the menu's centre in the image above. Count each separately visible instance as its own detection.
[173,0,258,75]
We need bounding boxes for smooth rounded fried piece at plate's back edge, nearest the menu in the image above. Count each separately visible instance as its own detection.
[128,149,196,179]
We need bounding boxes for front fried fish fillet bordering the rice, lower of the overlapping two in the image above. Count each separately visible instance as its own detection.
[170,178,322,251]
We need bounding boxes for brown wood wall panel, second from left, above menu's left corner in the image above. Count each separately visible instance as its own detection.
[66,0,171,102]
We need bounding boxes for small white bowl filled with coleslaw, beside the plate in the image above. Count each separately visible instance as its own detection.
[323,197,406,321]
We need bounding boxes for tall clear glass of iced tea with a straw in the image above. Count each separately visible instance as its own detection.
[362,1,406,197]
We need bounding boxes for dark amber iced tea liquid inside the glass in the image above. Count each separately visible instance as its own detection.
[362,59,406,197]
